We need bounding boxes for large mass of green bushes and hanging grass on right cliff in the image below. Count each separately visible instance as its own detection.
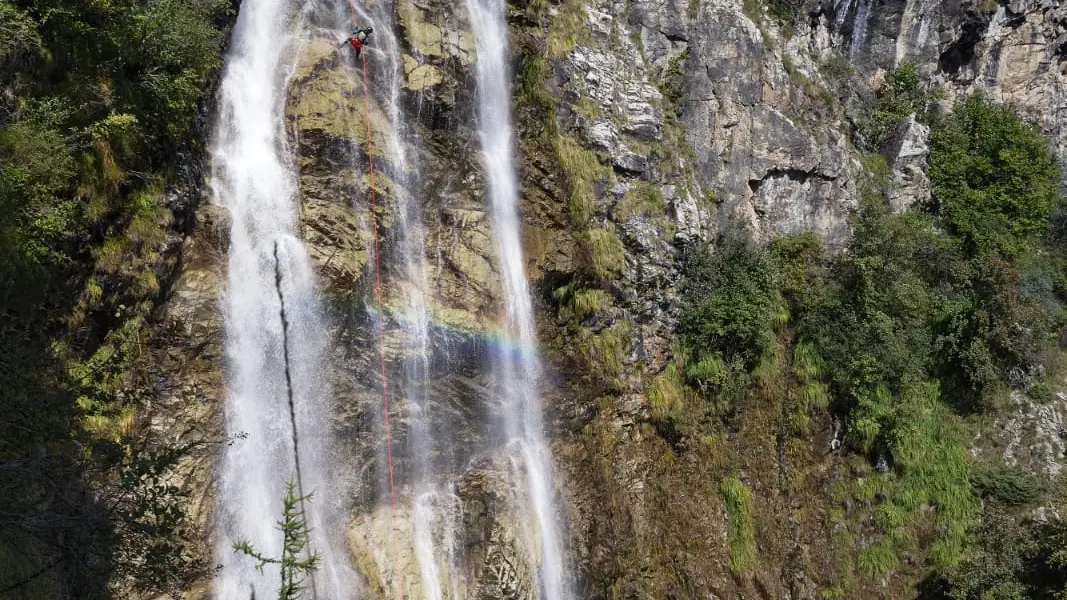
[665,93,1067,585]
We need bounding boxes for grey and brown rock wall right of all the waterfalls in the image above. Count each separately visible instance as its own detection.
[527,1,1067,598]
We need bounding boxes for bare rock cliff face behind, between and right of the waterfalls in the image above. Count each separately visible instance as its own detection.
[152,0,1067,599]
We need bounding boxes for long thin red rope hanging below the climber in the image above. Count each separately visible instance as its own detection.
[348,0,403,600]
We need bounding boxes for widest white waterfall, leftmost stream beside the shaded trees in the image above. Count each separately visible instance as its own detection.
[210,0,355,600]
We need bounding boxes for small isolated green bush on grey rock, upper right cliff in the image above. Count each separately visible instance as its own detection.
[857,63,931,152]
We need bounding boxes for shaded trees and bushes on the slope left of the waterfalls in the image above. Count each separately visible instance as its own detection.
[0,0,230,598]
